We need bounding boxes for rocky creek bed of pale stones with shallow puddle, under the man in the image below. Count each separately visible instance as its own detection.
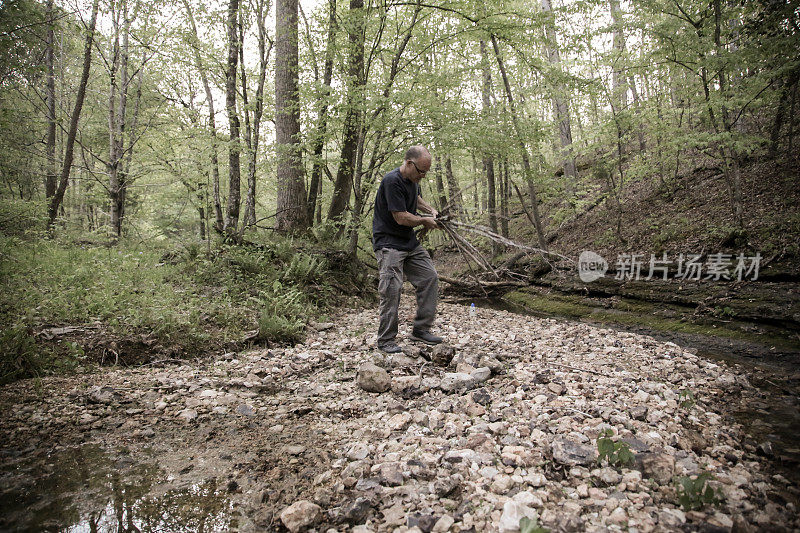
[0,297,800,532]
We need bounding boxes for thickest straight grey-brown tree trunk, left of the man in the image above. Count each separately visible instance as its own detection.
[275,0,310,233]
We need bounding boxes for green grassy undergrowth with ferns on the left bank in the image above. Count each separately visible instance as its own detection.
[0,227,356,383]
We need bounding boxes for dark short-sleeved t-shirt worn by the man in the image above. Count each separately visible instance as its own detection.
[372,168,421,251]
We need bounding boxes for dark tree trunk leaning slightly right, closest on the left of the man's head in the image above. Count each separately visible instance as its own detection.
[328,0,365,227]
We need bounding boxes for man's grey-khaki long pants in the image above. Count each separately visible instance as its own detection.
[375,246,439,347]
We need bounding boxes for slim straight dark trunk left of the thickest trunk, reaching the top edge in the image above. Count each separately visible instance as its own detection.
[223,0,241,240]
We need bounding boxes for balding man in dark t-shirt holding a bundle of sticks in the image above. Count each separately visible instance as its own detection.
[372,146,442,353]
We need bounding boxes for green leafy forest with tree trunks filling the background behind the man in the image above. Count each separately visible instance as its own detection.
[0,0,800,246]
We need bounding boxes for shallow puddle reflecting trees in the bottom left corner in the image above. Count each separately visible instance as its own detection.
[0,446,236,533]
